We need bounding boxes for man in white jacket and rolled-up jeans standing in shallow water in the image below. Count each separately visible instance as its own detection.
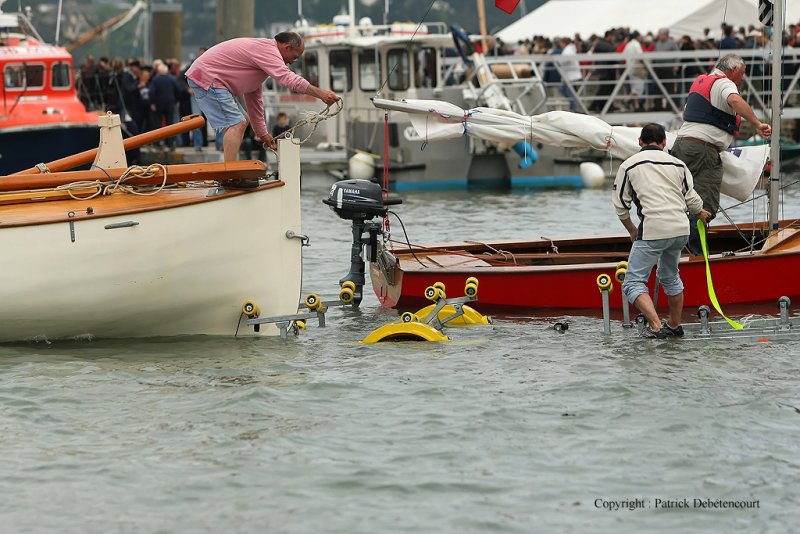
[613,124,710,339]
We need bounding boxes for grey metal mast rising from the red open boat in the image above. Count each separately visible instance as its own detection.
[767,0,783,231]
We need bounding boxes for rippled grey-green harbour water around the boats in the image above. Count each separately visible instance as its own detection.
[0,182,800,533]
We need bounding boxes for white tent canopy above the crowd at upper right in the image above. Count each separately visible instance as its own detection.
[496,0,800,43]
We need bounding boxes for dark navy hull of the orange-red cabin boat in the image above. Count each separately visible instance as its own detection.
[0,122,100,176]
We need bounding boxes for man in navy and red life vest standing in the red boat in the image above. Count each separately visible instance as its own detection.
[672,54,772,256]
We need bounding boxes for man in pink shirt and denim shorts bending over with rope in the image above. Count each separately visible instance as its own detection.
[186,32,340,161]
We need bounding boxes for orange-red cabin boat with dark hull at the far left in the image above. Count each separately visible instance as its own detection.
[0,4,99,175]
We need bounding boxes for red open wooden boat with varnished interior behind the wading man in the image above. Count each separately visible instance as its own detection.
[370,221,800,314]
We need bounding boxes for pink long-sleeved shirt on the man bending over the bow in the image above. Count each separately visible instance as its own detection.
[186,37,309,137]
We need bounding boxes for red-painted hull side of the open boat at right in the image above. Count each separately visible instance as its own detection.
[370,234,800,314]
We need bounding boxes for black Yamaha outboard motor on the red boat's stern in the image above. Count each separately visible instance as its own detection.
[322,180,402,307]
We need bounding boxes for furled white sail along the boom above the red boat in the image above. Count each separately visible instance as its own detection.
[372,98,769,201]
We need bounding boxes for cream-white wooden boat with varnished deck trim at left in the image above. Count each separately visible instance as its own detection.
[0,117,301,342]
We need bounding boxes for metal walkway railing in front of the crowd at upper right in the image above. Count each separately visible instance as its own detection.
[487,48,800,124]
